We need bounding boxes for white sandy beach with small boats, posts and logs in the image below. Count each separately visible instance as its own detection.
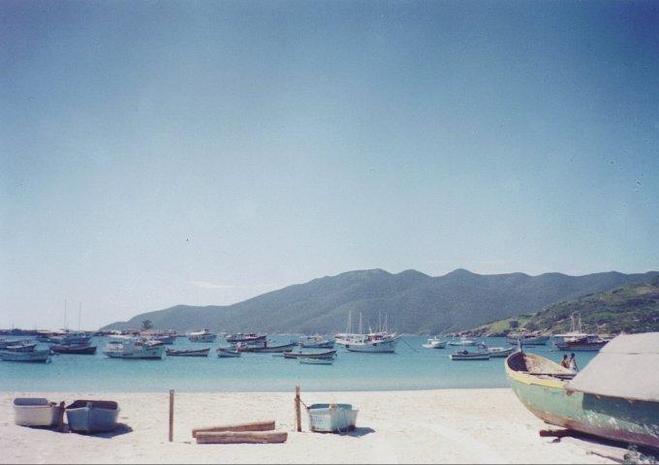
[0,389,624,463]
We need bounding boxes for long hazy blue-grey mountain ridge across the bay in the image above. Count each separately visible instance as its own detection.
[102,269,659,334]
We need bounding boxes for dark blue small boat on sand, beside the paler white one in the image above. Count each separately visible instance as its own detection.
[66,400,119,434]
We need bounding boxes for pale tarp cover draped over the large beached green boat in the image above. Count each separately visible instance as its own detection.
[567,333,659,402]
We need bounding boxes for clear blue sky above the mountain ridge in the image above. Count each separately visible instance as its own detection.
[0,0,659,329]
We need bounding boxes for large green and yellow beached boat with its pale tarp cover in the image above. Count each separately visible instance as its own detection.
[505,332,659,448]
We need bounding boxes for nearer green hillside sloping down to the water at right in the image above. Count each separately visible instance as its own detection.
[469,278,659,336]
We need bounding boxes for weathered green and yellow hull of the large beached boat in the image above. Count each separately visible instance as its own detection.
[506,354,659,448]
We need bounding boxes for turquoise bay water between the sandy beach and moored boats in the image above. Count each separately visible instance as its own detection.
[0,336,595,392]
